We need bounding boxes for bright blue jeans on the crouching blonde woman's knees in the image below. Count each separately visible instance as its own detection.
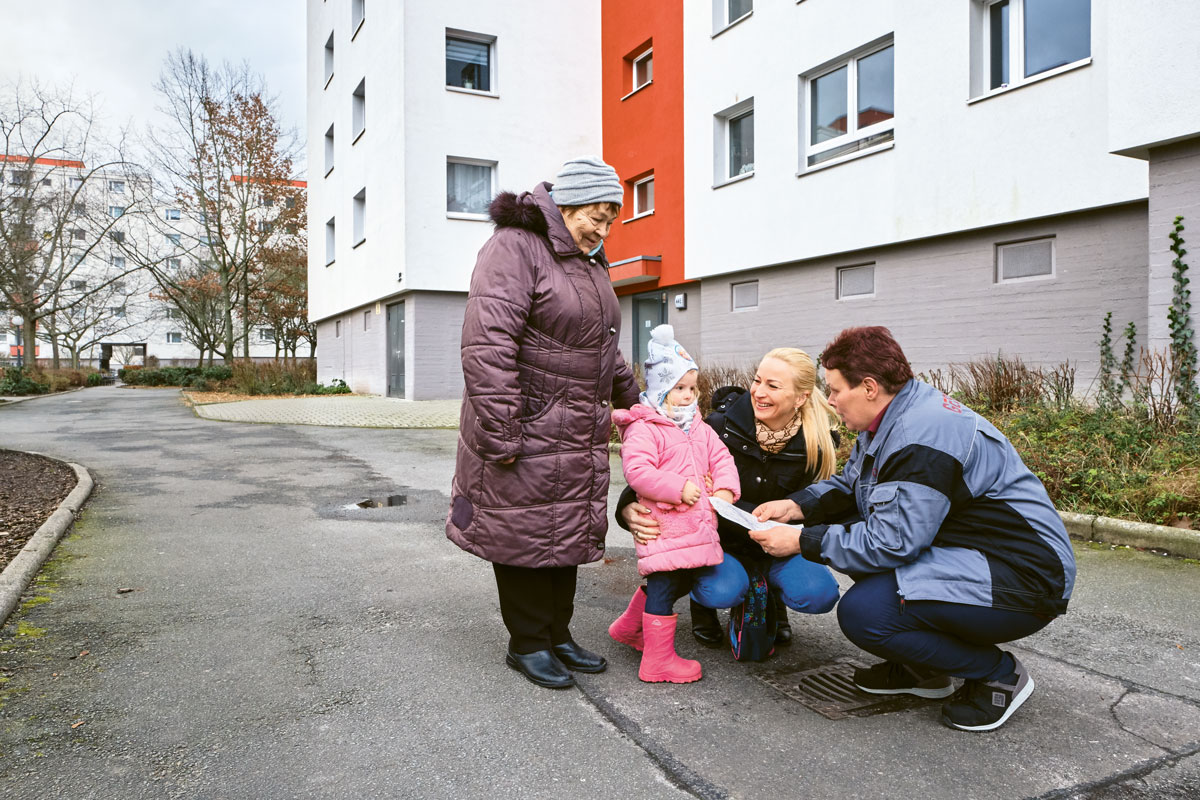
[691,553,838,614]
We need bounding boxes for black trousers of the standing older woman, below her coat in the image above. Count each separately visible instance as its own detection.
[492,564,578,655]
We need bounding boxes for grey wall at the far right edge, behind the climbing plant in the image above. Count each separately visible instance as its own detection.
[1147,139,1200,349]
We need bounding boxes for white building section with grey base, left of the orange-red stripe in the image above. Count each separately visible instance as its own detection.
[307,0,601,399]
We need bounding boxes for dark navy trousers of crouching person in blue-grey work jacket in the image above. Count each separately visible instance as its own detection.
[838,572,1050,680]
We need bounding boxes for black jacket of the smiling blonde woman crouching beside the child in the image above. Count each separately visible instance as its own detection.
[617,386,838,563]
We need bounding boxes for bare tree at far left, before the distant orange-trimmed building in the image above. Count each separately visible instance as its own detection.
[0,79,150,366]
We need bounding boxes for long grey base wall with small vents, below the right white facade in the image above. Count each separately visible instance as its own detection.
[701,203,1147,391]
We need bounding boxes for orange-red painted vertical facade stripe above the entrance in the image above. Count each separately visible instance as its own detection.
[600,0,684,295]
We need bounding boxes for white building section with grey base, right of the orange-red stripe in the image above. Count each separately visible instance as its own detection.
[684,0,1200,390]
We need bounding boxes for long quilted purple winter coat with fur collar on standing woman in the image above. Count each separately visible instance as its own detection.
[446,184,637,567]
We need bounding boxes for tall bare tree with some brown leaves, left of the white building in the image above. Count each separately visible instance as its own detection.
[146,49,299,361]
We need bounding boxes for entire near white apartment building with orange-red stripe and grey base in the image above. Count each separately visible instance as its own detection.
[308,0,1200,399]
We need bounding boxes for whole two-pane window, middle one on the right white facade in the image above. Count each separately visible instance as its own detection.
[800,41,895,167]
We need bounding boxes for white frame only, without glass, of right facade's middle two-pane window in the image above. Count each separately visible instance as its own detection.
[797,34,895,175]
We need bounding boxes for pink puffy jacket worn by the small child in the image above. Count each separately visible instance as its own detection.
[612,403,742,575]
